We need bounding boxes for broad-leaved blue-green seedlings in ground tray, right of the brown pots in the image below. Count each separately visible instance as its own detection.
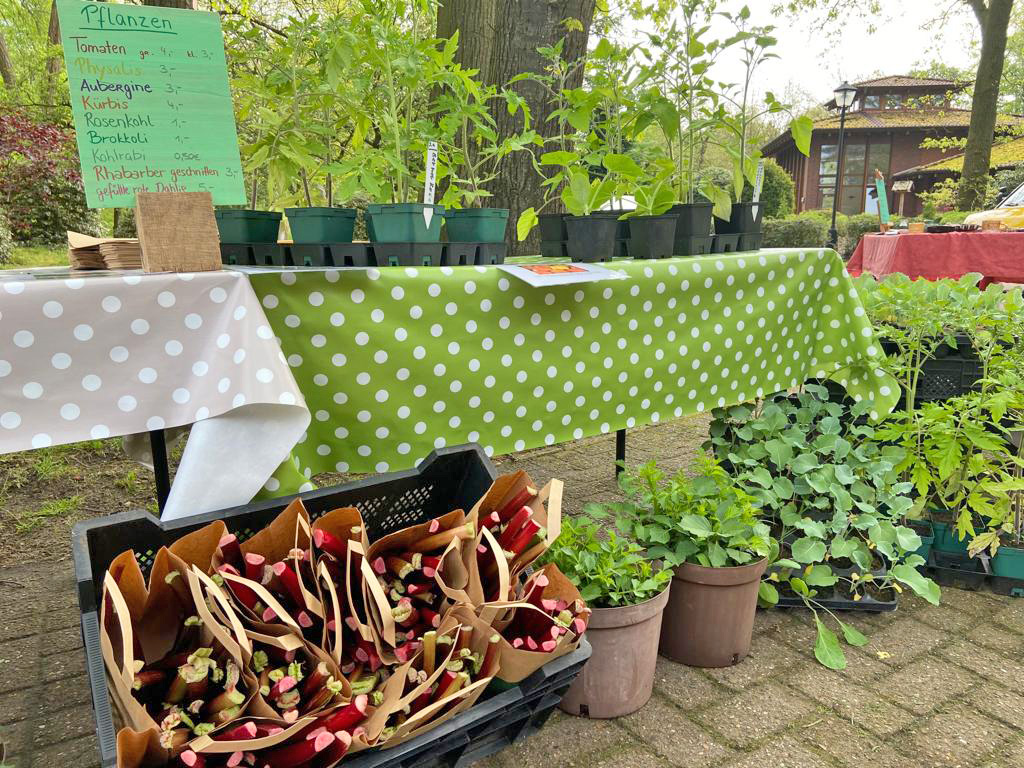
[706,385,939,669]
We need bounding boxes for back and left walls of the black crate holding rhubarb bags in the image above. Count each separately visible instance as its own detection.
[72,444,503,768]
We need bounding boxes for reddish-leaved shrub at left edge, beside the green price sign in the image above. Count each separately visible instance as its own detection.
[0,113,98,245]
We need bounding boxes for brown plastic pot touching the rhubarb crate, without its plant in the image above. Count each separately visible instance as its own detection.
[559,585,671,719]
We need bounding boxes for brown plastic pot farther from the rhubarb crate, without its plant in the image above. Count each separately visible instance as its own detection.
[659,559,768,667]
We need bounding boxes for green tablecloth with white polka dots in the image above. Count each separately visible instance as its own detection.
[250,250,898,494]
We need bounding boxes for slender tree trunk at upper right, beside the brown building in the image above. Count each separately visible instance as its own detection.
[956,0,1013,211]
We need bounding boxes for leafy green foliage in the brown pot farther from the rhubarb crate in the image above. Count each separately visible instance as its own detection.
[590,456,771,568]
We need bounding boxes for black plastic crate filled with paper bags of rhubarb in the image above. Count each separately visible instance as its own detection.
[72,444,590,768]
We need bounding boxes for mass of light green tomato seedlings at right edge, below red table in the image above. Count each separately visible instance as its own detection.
[857,274,1024,552]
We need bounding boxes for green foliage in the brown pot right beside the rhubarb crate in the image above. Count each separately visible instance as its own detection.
[543,514,672,608]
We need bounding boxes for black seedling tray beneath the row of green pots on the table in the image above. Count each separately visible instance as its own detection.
[226,243,508,267]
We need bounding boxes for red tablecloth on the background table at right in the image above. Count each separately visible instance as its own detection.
[847,231,1024,284]
